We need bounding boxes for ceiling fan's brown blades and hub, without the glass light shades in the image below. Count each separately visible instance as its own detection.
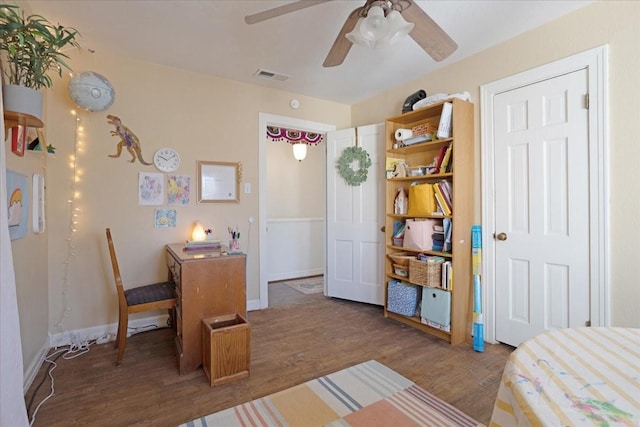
[244,0,458,67]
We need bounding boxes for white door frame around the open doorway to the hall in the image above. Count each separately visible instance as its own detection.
[258,113,336,309]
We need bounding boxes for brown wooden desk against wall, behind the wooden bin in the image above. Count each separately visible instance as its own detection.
[167,243,247,375]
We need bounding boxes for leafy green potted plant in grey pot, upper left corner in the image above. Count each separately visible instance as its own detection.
[0,4,79,119]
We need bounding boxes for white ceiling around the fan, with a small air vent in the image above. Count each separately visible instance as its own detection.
[25,0,591,104]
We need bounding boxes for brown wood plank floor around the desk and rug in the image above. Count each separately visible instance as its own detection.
[25,283,512,426]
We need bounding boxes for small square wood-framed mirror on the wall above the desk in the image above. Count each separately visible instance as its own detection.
[198,160,242,203]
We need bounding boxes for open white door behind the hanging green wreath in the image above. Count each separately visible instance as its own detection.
[326,124,385,305]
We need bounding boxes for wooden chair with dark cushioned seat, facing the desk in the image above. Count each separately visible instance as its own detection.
[107,228,176,366]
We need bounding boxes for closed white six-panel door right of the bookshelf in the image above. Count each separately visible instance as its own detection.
[494,70,590,346]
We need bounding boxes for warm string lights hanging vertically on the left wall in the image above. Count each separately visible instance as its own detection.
[56,110,84,332]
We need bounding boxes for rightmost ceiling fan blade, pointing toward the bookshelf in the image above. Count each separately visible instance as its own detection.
[402,1,458,62]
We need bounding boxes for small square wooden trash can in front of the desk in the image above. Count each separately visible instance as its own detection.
[202,313,251,386]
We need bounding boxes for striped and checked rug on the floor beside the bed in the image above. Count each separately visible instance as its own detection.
[183,360,481,427]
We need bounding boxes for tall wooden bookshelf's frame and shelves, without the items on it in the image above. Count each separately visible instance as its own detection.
[384,99,474,344]
